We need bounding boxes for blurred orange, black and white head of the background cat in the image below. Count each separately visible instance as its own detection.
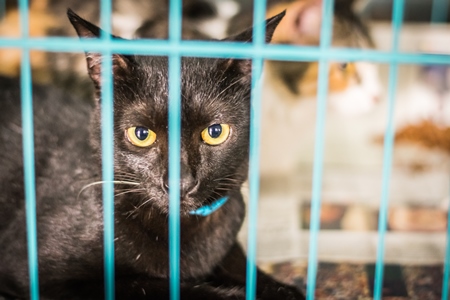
[267,0,381,114]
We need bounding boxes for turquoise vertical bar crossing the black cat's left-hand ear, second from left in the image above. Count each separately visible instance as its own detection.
[100,0,115,300]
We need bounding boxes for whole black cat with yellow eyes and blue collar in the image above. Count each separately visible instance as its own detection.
[0,10,304,299]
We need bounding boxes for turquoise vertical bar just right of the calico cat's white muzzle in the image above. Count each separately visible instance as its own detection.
[373,0,404,300]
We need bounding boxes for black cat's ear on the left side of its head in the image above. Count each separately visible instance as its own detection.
[67,8,133,88]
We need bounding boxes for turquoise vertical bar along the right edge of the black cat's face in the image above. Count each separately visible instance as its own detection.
[246,0,266,299]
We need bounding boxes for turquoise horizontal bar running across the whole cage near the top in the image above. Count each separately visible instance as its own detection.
[0,38,450,65]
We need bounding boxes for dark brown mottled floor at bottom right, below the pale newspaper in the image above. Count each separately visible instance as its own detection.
[261,262,443,300]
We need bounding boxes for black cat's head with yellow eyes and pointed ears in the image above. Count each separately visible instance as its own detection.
[68,10,284,215]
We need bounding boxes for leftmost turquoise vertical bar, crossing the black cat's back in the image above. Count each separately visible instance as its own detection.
[19,0,39,300]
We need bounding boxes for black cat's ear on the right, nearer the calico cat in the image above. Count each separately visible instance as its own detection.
[220,11,286,79]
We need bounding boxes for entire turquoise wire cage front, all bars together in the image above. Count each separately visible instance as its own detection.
[0,0,450,300]
